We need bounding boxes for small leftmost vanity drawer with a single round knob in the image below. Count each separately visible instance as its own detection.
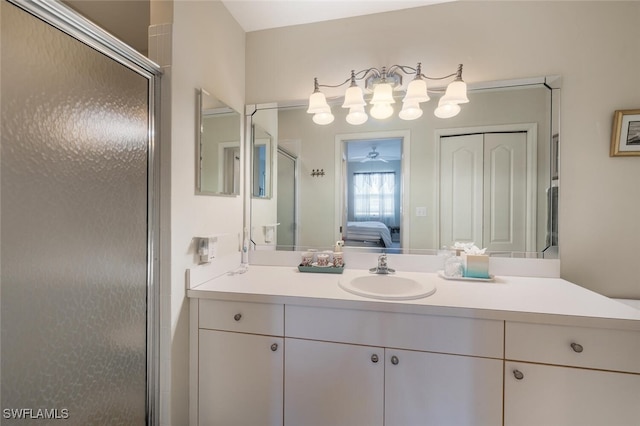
[198,299,284,336]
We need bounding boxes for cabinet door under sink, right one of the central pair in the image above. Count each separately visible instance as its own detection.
[384,349,503,426]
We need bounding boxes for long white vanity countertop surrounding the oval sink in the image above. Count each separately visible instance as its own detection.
[187,265,640,331]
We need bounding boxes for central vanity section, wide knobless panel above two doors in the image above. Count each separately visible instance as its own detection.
[285,305,503,426]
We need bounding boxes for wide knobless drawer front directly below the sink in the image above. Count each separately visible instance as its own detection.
[285,305,504,358]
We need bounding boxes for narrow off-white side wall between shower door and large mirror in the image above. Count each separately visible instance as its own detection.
[149,1,245,426]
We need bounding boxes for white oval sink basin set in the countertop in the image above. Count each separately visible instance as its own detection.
[338,275,436,300]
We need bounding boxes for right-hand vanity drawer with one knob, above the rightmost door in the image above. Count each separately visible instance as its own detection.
[505,322,640,373]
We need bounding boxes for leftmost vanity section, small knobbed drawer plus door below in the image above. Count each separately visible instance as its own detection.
[192,299,284,426]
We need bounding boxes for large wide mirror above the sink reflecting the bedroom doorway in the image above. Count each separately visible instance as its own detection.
[251,77,560,258]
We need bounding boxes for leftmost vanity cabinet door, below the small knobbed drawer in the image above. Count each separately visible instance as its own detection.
[198,330,284,426]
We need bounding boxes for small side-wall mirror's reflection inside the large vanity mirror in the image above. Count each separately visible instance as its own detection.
[251,124,273,198]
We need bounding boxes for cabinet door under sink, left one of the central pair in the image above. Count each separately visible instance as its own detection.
[284,339,384,426]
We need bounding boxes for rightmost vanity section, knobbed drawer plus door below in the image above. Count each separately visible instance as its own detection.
[504,322,640,426]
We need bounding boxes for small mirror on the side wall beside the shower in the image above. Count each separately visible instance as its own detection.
[196,89,242,196]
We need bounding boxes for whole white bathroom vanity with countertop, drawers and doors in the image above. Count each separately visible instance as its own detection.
[188,265,640,426]
